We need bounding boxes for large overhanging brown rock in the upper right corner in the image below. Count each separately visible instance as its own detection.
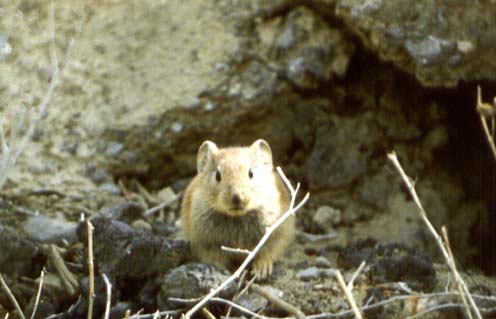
[336,0,496,87]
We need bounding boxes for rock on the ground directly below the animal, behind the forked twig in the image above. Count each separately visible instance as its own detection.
[158,263,236,309]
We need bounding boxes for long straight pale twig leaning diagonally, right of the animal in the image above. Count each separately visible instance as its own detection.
[388,152,482,319]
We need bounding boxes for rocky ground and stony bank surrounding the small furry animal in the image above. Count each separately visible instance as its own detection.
[0,0,496,319]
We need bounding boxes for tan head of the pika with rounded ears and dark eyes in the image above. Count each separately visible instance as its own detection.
[197,139,277,216]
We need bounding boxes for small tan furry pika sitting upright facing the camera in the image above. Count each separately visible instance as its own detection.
[181,139,295,278]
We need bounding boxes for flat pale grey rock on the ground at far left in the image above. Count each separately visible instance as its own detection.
[23,215,77,243]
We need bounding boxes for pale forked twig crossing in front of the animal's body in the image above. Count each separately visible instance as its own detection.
[184,167,310,319]
